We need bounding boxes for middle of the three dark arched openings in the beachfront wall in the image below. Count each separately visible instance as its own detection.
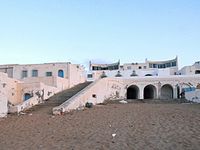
[144,84,156,99]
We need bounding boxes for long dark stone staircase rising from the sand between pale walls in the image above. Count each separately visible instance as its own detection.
[25,82,92,114]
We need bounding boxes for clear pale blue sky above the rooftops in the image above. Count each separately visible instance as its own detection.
[0,0,200,67]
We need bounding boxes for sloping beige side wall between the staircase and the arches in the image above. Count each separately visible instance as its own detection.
[53,78,125,114]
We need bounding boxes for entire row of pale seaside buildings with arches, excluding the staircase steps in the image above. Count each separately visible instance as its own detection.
[0,57,200,116]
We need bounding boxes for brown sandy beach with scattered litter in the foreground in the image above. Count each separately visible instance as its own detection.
[0,103,200,150]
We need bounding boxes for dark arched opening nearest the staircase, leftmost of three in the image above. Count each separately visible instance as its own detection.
[127,85,139,99]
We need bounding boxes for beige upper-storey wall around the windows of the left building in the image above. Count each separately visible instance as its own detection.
[0,63,86,88]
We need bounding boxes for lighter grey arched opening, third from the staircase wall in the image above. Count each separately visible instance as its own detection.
[161,84,173,99]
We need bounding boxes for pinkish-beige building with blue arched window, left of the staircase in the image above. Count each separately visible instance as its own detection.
[0,62,86,115]
